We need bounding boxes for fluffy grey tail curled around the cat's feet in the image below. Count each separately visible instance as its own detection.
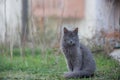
[64,70,94,78]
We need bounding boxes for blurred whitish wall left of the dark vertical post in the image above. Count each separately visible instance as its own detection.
[0,0,21,42]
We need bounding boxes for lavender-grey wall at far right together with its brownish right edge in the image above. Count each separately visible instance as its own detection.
[96,0,120,31]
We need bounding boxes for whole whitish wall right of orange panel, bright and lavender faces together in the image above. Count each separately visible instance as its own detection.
[78,0,120,38]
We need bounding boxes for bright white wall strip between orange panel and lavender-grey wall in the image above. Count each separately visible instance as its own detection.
[78,0,96,39]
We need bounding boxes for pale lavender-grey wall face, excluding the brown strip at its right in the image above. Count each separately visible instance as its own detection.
[96,0,114,31]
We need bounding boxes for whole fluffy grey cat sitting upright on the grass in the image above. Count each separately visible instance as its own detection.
[61,27,96,78]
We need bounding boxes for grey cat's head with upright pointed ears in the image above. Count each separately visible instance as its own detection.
[63,27,79,46]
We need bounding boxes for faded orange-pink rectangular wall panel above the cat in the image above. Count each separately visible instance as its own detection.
[33,0,85,18]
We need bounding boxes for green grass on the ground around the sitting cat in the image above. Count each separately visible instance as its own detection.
[0,49,120,80]
